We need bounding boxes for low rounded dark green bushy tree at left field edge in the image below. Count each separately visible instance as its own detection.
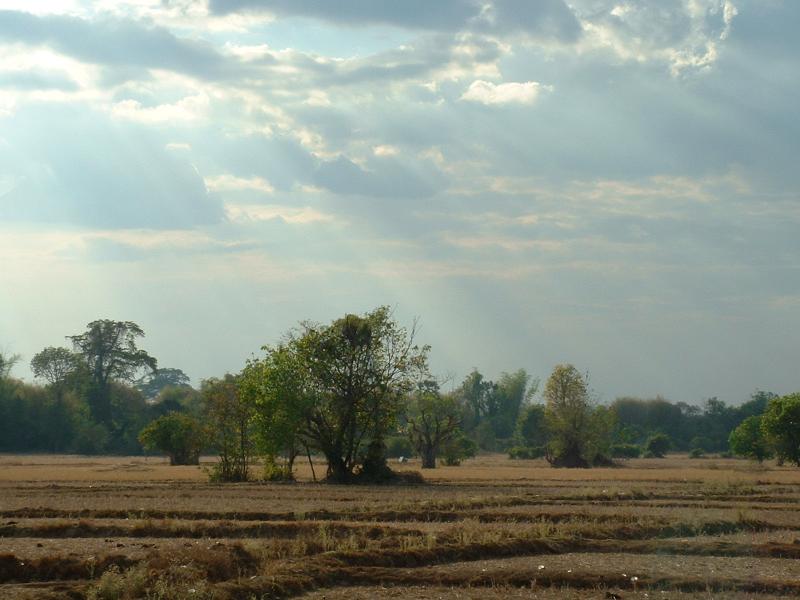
[139,412,206,465]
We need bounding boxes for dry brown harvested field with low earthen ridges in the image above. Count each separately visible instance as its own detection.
[0,456,800,600]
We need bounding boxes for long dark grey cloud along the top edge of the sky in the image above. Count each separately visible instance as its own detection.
[210,0,581,41]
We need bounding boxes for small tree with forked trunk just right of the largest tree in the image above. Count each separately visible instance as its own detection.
[406,380,461,469]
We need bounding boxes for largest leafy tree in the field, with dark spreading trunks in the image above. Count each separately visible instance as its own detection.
[278,307,428,483]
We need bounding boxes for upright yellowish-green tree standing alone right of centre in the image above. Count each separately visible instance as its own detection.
[544,364,614,467]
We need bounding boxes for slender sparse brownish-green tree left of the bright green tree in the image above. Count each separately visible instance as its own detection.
[201,374,253,481]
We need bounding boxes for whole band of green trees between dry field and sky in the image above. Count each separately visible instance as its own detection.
[0,307,800,482]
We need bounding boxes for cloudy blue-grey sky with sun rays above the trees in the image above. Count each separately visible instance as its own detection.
[0,0,800,404]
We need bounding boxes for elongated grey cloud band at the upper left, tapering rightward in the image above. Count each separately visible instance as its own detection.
[0,10,240,79]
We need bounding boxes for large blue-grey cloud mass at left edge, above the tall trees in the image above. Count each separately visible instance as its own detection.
[0,108,223,229]
